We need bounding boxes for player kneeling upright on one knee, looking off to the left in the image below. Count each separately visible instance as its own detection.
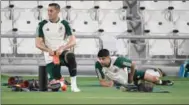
[36,3,80,92]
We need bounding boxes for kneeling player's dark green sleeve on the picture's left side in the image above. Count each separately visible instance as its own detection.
[37,20,47,38]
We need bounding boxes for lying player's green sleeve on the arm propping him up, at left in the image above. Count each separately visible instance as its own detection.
[95,62,105,79]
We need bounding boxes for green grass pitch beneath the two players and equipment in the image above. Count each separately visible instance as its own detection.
[1,76,189,104]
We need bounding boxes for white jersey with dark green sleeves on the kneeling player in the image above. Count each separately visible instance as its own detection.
[37,19,72,64]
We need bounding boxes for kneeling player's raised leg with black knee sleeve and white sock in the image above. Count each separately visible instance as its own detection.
[60,51,80,92]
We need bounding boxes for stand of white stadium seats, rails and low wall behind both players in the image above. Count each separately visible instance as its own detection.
[1,0,189,76]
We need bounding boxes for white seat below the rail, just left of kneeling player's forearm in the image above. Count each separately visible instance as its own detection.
[17,38,42,54]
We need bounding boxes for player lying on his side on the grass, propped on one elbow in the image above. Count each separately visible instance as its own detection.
[95,49,173,87]
